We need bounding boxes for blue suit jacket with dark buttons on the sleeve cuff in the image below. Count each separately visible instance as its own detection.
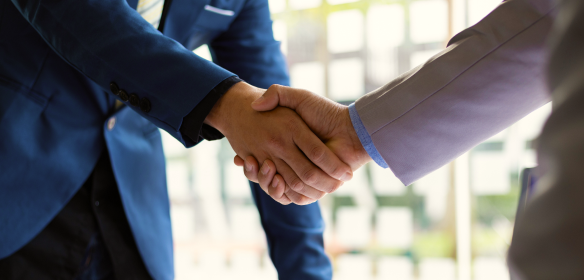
[0,0,331,279]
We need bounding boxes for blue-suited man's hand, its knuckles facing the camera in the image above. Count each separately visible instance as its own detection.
[205,82,353,204]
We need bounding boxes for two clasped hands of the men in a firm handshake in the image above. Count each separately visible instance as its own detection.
[205,82,371,205]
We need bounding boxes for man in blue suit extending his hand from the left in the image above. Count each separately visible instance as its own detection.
[0,0,351,279]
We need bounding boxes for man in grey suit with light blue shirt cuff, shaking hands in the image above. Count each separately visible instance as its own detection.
[236,0,584,279]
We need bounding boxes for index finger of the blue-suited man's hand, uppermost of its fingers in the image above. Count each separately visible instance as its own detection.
[293,126,353,184]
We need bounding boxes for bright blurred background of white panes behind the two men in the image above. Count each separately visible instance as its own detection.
[163,0,551,280]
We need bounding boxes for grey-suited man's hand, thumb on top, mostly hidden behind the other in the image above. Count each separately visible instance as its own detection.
[234,85,371,201]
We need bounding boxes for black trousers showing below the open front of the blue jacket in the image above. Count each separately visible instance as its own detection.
[0,152,146,280]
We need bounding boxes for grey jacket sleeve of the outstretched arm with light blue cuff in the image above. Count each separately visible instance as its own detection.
[355,0,554,185]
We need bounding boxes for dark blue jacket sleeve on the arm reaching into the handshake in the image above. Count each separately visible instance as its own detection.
[12,0,234,146]
